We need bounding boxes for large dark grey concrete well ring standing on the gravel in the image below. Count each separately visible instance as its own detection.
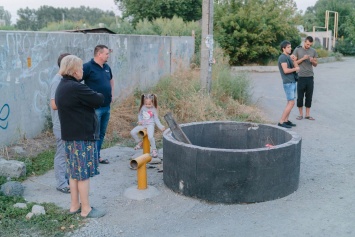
[163,121,302,203]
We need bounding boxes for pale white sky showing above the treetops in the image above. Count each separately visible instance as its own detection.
[0,0,317,24]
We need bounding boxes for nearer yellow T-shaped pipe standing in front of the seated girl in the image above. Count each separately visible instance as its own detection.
[130,153,152,189]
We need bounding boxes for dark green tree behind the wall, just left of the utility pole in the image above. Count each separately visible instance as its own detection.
[115,0,202,25]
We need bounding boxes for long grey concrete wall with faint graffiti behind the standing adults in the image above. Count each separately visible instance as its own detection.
[0,31,194,147]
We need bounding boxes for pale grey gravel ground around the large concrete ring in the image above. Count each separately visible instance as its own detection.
[24,58,355,237]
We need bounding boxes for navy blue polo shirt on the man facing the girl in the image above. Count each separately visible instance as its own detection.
[83,58,112,107]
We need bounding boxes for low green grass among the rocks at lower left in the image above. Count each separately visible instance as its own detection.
[0,150,83,237]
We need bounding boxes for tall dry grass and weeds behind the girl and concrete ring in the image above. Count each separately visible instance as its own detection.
[106,61,265,146]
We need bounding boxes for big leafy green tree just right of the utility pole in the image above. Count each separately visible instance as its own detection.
[214,0,301,65]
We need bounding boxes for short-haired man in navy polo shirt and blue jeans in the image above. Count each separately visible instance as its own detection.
[83,45,114,164]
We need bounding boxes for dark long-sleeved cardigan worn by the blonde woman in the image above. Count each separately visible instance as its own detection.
[55,76,104,141]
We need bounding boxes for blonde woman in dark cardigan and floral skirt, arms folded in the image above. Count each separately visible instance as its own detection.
[55,55,105,218]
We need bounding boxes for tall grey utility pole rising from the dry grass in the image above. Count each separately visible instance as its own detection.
[200,0,214,94]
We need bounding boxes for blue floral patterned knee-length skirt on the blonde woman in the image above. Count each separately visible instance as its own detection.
[64,141,100,180]
